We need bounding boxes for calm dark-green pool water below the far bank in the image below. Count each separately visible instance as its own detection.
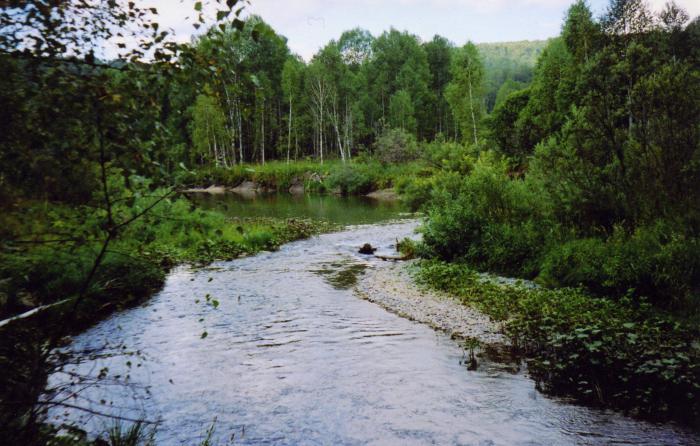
[191,193,410,225]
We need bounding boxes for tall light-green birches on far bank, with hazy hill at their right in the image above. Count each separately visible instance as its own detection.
[170,17,542,166]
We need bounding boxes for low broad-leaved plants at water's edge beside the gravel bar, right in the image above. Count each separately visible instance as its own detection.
[414,260,700,426]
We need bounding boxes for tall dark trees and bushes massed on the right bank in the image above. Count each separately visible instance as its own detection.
[414,0,700,310]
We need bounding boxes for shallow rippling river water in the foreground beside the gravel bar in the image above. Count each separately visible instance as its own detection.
[46,199,699,445]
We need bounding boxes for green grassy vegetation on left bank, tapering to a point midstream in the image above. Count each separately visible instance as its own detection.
[0,197,336,316]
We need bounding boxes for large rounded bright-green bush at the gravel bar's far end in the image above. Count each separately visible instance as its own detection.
[423,155,554,277]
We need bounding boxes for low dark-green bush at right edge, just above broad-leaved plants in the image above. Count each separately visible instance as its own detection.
[539,225,700,308]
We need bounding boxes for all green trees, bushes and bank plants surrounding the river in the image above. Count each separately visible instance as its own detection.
[0,0,700,444]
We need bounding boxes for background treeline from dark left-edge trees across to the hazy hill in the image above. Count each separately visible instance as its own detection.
[0,16,544,202]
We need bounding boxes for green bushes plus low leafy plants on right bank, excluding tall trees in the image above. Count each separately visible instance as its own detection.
[397,142,700,425]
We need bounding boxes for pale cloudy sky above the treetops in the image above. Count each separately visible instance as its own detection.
[148,0,700,60]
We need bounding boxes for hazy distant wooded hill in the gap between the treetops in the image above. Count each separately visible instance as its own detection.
[476,40,547,112]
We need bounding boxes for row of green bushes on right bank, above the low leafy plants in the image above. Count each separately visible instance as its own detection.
[418,154,700,312]
